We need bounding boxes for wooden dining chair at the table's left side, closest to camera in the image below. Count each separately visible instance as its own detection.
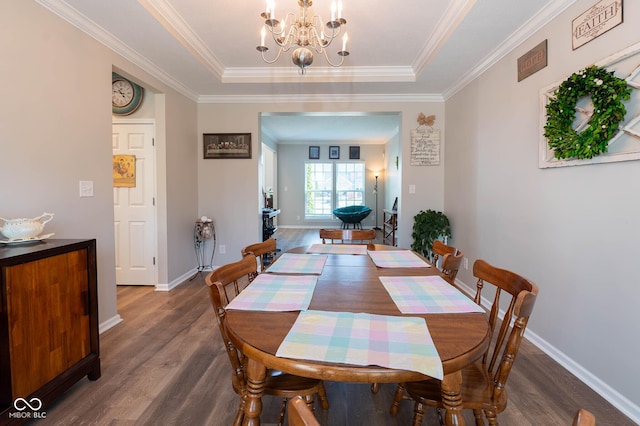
[205,256,329,426]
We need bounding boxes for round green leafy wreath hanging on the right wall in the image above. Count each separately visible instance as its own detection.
[544,65,631,159]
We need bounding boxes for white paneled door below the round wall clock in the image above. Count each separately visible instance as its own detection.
[112,122,156,285]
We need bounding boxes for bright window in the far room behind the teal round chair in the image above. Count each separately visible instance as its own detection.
[304,162,365,219]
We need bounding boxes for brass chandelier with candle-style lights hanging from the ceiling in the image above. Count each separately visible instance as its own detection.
[256,0,349,74]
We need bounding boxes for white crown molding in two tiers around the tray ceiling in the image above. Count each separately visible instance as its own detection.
[35,0,577,103]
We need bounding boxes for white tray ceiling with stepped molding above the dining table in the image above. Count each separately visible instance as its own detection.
[36,0,576,141]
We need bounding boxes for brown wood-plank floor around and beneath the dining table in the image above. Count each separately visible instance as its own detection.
[34,229,634,426]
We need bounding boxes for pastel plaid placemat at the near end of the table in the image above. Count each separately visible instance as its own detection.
[276,311,443,379]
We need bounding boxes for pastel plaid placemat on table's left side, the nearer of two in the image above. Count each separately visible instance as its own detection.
[227,274,318,311]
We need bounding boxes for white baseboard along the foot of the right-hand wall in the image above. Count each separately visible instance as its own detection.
[456,279,640,424]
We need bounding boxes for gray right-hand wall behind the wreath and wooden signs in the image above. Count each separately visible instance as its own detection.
[445,0,640,421]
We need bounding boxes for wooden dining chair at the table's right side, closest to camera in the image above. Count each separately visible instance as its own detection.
[390,260,538,425]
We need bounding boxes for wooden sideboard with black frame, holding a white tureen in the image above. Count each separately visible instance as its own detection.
[0,239,100,425]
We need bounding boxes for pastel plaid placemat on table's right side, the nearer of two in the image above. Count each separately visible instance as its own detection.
[379,276,484,314]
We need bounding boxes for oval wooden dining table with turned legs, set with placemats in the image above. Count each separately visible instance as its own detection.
[226,244,491,425]
